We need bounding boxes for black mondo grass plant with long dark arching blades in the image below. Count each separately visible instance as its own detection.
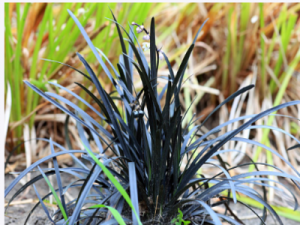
[5,8,300,224]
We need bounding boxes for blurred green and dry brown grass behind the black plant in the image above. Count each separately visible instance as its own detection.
[4,3,300,220]
